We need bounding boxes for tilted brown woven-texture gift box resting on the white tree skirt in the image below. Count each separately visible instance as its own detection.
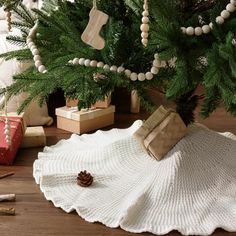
[134,106,187,160]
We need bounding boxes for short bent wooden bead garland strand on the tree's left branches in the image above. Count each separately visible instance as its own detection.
[26,23,47,73]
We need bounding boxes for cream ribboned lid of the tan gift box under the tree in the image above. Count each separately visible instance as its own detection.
[56,105,115,121]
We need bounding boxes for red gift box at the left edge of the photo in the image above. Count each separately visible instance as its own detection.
[0,117,24,165]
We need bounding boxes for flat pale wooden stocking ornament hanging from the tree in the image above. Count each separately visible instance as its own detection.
[81,0,108,50]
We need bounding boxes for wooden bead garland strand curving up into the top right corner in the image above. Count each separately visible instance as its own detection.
[181,0,236,36]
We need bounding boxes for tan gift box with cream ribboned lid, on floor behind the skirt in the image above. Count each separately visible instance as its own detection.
[56,106,115,134]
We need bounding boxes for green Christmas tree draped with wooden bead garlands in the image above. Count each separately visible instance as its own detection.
[0,0,236,124]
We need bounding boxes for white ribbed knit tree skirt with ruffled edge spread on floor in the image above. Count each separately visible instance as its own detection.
[34,121,236,235]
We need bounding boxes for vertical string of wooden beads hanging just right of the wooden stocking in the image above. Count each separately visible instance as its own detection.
[140,0,149,47]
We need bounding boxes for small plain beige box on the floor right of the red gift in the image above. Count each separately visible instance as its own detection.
[20,126,46,148]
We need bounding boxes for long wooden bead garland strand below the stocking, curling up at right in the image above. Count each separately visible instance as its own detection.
[68,54,161,81]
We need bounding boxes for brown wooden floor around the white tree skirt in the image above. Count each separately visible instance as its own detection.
[0,109,236,236]
